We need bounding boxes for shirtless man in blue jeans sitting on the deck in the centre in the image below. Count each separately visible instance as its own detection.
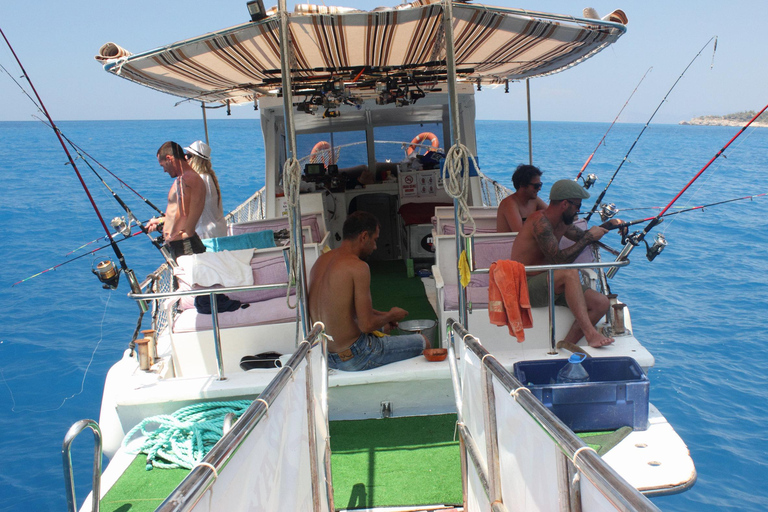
[309,211,428,371]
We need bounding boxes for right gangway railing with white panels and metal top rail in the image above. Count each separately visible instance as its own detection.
[447,319,658,512]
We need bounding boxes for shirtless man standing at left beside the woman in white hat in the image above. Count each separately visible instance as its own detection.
[147,141,205,259]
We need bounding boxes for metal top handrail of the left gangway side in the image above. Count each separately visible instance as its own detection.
[157,323,326,512]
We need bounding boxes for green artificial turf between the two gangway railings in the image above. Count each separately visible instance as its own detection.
[330,414,462,509]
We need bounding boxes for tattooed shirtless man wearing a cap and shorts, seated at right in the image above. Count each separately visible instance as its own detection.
[510,180,613,347]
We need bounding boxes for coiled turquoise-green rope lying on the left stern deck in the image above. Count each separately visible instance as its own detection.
[123,400,251,471]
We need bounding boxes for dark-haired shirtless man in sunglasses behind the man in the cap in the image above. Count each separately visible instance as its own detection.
[496,164,547,233]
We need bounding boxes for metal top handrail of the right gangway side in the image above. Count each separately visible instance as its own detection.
[447,318,659,512]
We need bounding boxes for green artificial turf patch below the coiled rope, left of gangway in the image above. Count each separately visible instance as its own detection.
[100,453,189,512]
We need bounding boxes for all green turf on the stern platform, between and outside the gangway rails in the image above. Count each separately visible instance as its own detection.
[97,414,640,512]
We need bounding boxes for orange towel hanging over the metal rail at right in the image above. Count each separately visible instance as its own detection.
[488,260,533,343]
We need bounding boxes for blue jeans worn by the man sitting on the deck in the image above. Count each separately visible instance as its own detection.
[328,333,424,372]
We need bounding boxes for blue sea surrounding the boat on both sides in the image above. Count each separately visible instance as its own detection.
[0,119,768,512]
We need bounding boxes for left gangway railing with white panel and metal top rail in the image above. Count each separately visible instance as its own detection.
[157,323,334,512]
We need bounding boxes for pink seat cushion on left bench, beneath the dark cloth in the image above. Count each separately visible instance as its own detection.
[173,295,296,333]
